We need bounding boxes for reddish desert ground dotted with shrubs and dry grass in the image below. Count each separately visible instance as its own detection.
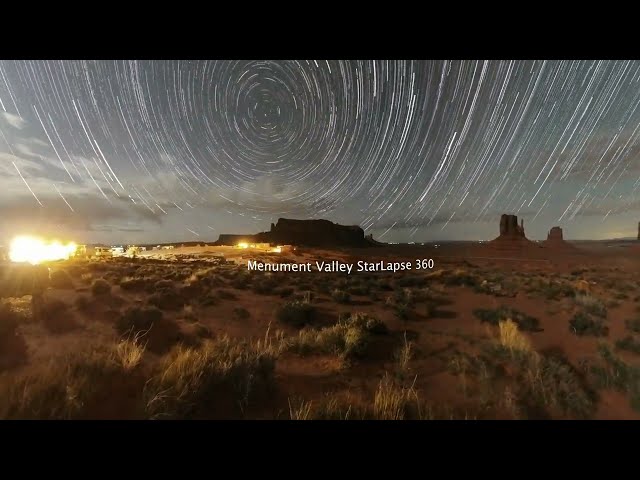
[0,242,640,420]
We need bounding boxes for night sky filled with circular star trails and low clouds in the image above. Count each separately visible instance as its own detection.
[0,60,640,243]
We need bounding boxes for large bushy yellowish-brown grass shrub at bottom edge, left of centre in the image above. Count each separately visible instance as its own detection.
[144,337,276,419]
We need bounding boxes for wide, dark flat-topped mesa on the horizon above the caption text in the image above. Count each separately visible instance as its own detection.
[216,218,377,247]
